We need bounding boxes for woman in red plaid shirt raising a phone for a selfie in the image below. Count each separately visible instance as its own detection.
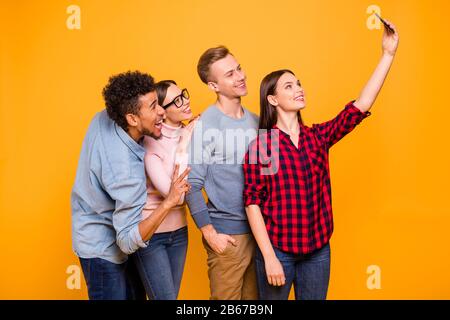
[244,20,399,299]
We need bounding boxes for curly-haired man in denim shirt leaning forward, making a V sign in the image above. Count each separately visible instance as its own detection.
[71,71,190,299]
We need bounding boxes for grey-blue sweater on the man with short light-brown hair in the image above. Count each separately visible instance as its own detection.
[186,105,259,234]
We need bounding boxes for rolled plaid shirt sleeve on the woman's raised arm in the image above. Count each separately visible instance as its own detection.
[313,100,371,148]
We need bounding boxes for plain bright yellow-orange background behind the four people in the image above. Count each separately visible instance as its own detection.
[0,0,450,299]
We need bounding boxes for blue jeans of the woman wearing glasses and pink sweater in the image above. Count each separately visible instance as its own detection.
[134,227,188,300]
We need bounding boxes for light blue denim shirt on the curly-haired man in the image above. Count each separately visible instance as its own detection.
[71,110,147,263]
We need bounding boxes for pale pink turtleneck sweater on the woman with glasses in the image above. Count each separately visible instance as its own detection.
[142,123,187,233]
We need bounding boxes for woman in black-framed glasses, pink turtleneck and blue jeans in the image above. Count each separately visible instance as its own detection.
[134,80,197,300]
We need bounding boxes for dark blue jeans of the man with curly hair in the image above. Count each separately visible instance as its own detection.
[79,257,145,300]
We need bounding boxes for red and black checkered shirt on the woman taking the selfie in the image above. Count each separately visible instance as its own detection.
[244,101,370,254]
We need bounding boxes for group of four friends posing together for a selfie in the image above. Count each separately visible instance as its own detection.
[71,20,399,300]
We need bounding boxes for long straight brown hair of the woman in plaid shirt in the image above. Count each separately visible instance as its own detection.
[259,69,303,130]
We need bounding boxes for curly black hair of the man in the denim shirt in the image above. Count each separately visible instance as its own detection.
[102,71,155,131]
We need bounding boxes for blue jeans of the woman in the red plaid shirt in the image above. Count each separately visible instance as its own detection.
[255,244,330,300]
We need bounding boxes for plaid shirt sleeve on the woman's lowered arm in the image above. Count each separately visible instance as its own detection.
[243,139,267,207]
